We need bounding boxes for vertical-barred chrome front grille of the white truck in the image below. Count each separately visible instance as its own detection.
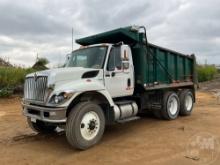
[24,76,47,102]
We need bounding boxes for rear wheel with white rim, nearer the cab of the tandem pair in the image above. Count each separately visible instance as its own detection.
[161,91,180,120]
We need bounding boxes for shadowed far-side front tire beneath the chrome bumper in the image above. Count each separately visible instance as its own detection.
[27,118,57,133]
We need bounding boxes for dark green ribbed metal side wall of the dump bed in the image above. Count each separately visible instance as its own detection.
[132,44,194,86]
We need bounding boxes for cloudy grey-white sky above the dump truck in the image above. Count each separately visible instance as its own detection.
[0,0,220,67]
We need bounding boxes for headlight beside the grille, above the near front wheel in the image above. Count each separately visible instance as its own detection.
[49,92,73,104]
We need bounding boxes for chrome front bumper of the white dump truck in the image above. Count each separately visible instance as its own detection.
[22,102,67,123]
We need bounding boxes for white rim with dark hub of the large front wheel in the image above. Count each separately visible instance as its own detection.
[80,111,100,140]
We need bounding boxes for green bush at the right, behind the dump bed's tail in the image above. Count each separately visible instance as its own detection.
[197,65,217,82]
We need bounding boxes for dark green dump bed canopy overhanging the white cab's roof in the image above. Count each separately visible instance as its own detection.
[76,26,139,46]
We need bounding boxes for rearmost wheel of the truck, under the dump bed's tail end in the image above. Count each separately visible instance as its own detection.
[179,89,194,116]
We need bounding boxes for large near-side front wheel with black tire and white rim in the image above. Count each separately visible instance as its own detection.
[66,102,105,150]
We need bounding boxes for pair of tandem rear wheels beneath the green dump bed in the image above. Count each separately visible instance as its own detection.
[154,89,194,120]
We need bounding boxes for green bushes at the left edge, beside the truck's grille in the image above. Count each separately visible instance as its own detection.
[0,67,35,97]
